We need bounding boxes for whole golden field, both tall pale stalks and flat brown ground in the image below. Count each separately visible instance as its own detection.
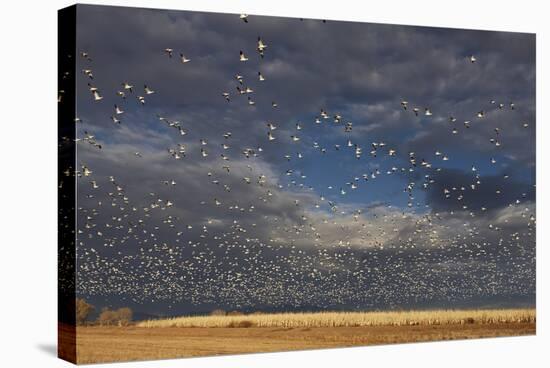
[77,309,536,364]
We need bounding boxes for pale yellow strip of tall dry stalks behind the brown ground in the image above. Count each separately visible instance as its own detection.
[136,309,536,328]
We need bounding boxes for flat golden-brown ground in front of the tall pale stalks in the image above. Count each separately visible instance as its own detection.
[73,323,535,364]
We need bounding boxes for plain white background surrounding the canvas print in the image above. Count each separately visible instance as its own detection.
[0,0,550,368]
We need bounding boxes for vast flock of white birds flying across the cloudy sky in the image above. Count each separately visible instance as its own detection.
[60,14,536,309]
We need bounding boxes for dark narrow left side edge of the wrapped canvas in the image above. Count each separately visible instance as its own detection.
[57,5,77,364]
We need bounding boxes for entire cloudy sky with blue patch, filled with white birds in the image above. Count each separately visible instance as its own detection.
[70,5,536,315]
